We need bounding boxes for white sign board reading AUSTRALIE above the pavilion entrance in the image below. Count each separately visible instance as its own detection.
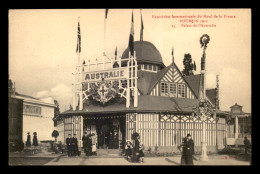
[82,67,127,82]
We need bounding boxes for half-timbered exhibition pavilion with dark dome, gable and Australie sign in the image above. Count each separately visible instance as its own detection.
[57,41,226,152]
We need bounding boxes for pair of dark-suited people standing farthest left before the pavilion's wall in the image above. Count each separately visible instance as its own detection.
[66,134,80,157]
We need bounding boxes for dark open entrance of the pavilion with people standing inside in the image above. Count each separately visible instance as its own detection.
[84,116,125,149]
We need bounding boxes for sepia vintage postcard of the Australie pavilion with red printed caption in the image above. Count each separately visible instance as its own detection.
[8,8,252,166]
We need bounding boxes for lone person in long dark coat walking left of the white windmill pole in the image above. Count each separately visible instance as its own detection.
[184,134,194,166]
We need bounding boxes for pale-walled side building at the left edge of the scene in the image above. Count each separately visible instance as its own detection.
[9,79,55,143]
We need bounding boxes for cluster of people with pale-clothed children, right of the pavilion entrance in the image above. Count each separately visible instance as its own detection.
[125,135,144,163]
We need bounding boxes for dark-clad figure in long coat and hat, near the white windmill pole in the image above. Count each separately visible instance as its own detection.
[181,134,194,165]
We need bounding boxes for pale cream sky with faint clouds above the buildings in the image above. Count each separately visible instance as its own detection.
[8,9,251,112]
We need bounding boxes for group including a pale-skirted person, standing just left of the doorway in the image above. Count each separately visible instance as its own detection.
[82,132,97,156]
